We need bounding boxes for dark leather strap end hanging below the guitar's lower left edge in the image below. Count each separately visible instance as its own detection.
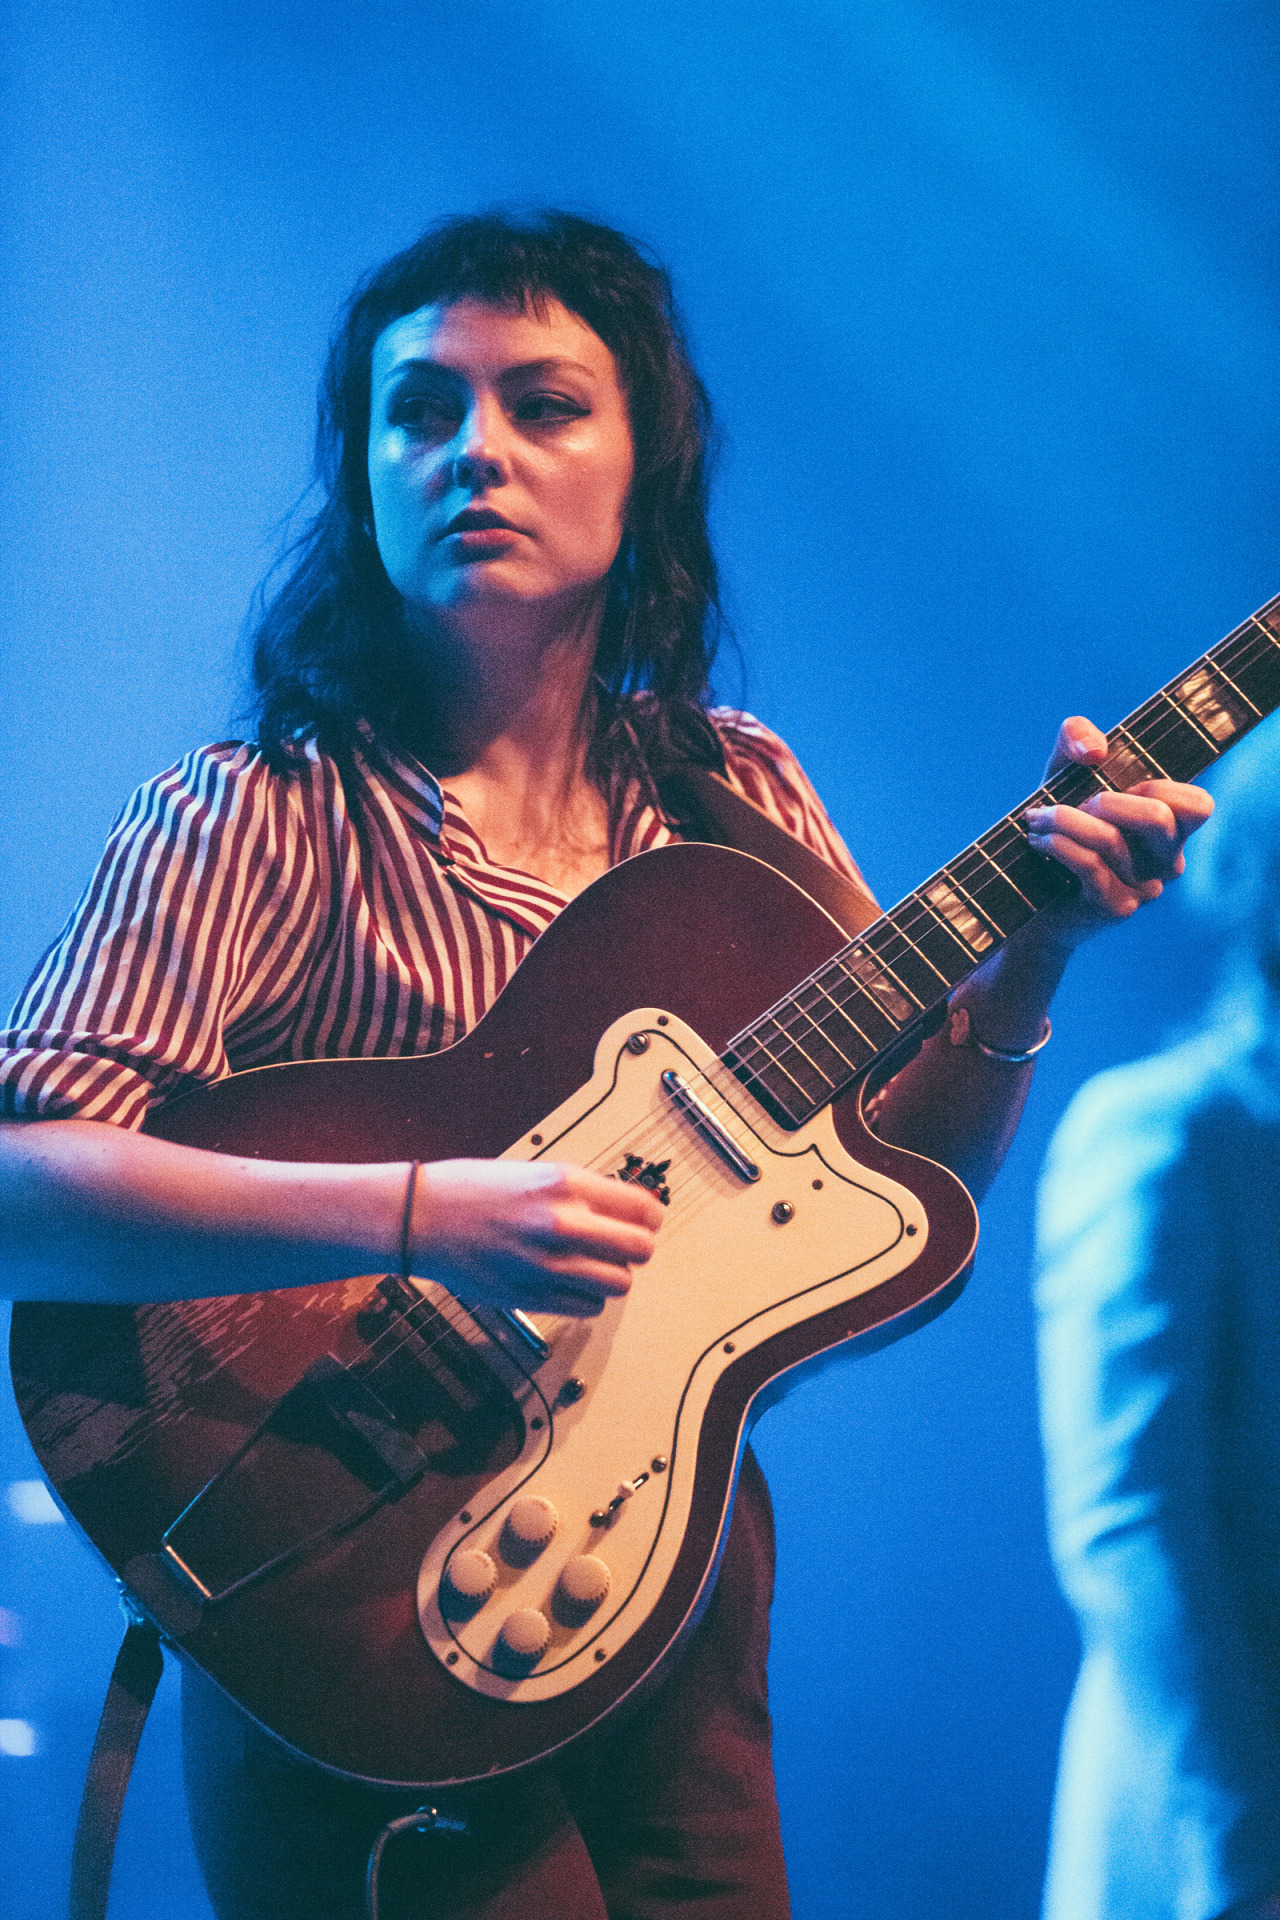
[67,1619,165,1920]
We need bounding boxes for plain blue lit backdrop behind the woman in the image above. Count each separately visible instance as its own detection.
[0,0,1280,1920]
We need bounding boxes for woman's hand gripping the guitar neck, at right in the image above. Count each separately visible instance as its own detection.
[1023,714,1213,947]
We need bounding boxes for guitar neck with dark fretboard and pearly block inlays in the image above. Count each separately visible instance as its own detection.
[723,595,1280,1129]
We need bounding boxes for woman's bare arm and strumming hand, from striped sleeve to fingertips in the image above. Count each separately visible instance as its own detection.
[0,1119,662,1315]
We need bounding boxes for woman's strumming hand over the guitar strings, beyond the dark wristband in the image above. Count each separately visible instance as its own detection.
[409,1160,662,1317]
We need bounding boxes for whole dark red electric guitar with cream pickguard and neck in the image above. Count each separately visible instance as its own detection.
[10,597,1280,1789]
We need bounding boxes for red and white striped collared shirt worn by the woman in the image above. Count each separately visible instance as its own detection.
[0,710,858,1127]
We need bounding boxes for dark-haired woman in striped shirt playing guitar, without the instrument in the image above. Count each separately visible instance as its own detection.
[0,213,1211,1920]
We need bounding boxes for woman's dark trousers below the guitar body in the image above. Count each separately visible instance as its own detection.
[182,1452,789,1920]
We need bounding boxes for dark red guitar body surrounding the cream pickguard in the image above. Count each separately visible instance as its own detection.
[12,845,977,1788]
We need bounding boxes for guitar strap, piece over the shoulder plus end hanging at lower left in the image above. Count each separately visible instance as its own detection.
[67,766,879,1920]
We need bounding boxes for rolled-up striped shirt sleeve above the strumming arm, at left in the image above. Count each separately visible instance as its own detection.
[0,743,317,1127]
